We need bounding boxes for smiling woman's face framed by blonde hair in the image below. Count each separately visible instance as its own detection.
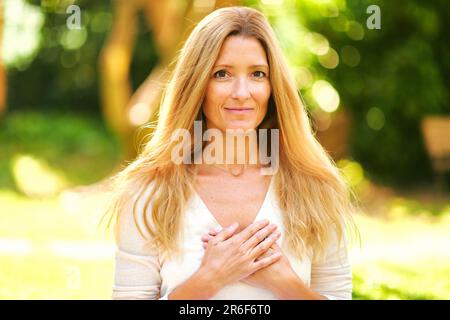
[203,36,271,132]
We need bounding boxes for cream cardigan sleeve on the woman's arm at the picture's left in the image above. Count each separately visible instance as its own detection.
[112,192,168,300]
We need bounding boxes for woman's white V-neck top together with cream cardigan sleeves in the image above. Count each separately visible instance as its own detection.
[112,178,352,300]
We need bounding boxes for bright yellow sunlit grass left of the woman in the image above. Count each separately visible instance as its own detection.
[0,190,114,299]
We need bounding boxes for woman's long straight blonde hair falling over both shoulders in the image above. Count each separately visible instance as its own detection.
[105,7,353,257]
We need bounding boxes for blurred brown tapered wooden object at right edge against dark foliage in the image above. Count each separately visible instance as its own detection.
[421,116,450,190]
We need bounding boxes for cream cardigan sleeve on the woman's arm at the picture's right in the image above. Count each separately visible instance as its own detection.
[311,228,352,300]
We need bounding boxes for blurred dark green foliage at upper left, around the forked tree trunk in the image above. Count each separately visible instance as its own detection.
[8,0,157,115]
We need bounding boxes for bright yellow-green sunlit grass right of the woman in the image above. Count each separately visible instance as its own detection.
[351,215,450,299]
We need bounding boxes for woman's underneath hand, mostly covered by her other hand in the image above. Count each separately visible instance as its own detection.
[202,225,296,292]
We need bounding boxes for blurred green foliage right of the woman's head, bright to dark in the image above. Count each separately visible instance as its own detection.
[249,0,450,186]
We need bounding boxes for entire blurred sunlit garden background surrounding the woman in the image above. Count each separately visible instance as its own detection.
[0,0,450,299]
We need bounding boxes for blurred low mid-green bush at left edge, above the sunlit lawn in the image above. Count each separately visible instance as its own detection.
[0,111,121,189]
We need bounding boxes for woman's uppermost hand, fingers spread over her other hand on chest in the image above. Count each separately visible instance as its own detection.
[199,220,282,287]
